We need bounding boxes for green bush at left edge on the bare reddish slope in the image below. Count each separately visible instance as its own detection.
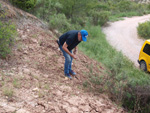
[0,21,16,58]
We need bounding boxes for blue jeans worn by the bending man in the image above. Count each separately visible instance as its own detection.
[59,45,73,74]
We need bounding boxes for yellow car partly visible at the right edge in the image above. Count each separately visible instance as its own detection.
[138,39,150,72]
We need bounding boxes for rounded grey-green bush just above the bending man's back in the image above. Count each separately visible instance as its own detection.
[49,14,74,32]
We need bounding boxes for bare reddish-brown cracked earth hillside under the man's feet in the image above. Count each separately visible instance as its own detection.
[0,1,125,113]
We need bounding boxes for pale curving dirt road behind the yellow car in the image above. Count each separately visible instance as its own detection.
[103,15,150,67]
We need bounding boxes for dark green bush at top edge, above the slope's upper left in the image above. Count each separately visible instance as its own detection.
[10,0,37,9]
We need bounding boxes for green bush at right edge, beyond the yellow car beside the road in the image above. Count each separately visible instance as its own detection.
[137,21,150,39]
